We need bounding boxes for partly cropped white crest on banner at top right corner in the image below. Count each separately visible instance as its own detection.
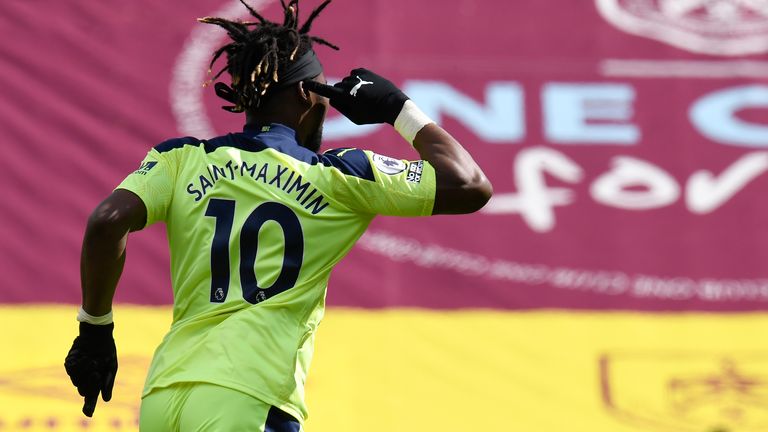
[595,0,768,56]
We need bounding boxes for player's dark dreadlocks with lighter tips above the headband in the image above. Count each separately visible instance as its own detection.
[198,0,339,113]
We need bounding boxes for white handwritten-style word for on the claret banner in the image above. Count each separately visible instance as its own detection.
[481,147,768,232]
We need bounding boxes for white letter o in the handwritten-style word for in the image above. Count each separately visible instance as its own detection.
[590,156,680,210]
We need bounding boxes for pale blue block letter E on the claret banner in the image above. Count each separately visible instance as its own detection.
[541,83,640,145]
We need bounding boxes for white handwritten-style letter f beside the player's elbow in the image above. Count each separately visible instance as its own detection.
[483,147,583,232]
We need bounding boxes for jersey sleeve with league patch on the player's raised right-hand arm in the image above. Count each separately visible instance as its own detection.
[323,149,436,216]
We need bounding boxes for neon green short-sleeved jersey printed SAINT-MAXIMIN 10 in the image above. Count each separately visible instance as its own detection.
[118,124,435,421]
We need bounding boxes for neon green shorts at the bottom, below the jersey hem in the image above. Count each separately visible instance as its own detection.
[139,382,301,432]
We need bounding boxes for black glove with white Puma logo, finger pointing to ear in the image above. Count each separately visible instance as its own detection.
[304,69,408,125]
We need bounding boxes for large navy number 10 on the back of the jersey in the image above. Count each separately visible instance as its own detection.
[205,198,304,304]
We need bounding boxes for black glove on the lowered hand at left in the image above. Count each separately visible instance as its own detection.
[64,322,117,417]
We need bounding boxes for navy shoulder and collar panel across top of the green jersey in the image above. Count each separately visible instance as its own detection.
[155,125,376,181]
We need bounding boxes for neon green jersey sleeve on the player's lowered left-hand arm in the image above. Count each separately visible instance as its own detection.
[115,149,176,227]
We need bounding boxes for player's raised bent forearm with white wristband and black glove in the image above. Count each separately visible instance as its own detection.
[304,69,493,214]
